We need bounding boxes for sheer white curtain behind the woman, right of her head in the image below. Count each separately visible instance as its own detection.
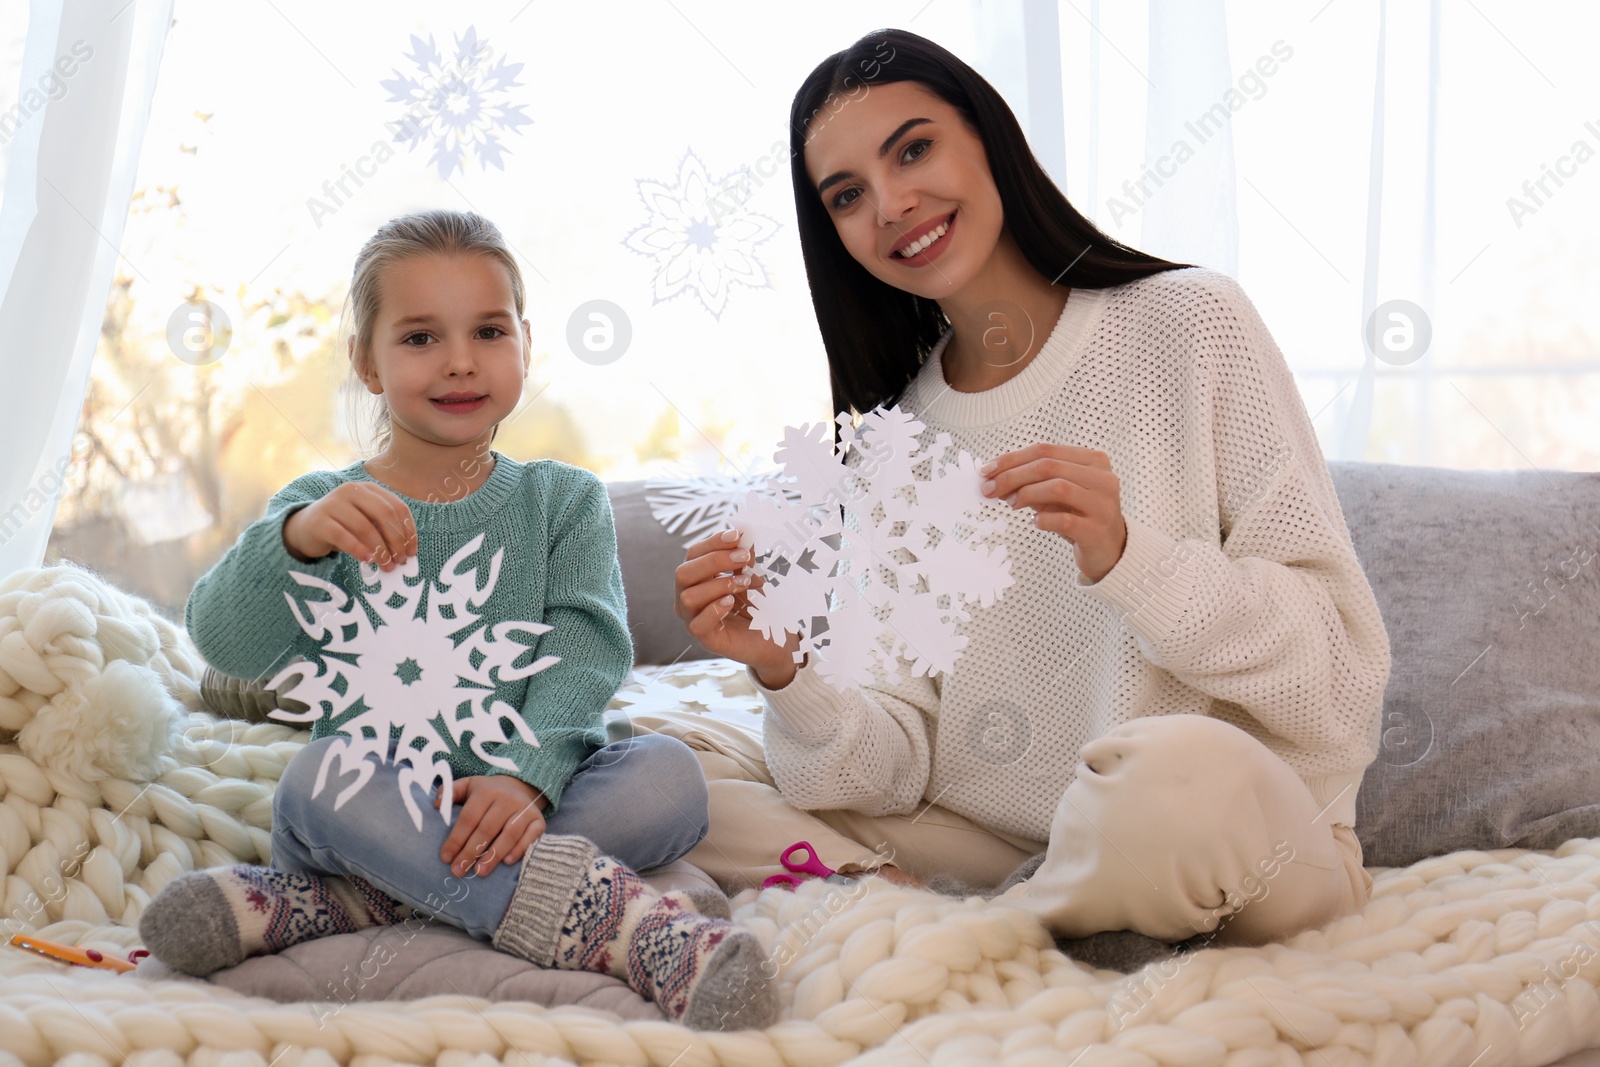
[979,0,1600,469]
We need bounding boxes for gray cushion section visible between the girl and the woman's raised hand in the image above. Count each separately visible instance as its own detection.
[606,478,712,664]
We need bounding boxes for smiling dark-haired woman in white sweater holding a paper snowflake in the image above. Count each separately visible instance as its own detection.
[677,30,1389,942]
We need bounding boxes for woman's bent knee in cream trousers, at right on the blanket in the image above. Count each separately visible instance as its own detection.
[998,715,1370,944]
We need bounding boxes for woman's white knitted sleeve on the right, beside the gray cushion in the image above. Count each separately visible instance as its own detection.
[1078,272,1389,761]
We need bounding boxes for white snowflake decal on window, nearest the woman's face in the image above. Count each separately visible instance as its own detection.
[622,149,778,318]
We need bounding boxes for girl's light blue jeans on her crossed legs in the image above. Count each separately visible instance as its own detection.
[272,734,710,941]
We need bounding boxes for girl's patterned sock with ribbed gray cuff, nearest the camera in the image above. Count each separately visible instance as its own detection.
[493,833,778,1030]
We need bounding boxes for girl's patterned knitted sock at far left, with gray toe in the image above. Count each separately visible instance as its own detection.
[139,864,411,977]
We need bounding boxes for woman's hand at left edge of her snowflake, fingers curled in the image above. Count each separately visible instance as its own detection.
[674,530,800,689]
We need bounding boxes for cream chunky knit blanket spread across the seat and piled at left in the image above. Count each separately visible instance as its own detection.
[0,568,1600,1067]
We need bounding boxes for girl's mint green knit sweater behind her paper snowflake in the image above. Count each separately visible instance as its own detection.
[184,451,634,814]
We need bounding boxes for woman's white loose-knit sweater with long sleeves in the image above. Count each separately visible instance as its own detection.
[752,267,1389,841]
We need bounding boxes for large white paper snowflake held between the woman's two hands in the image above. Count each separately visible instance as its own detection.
[733,408,1013,689]
